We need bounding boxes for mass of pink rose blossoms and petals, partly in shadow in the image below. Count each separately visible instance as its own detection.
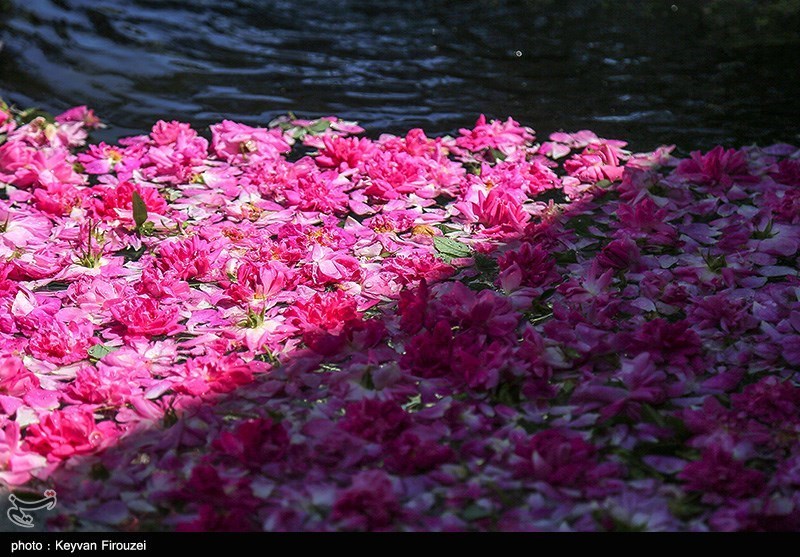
[0,99,800,530]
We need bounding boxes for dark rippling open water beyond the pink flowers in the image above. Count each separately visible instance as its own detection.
[0,0,800,149]
